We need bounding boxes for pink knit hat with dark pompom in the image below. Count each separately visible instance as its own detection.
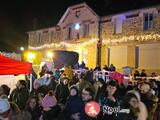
[42,91,57,108]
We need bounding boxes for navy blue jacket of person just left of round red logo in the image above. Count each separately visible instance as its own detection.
[64,96,85,120]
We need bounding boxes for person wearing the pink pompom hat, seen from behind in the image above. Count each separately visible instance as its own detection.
[41,91,60,120]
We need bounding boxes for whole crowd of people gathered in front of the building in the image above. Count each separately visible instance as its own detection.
[0,63,160,120]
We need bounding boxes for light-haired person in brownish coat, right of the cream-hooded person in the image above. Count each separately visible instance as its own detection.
[140,82,158,120]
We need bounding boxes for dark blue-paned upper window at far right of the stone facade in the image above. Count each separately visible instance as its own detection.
[143,13,153,30]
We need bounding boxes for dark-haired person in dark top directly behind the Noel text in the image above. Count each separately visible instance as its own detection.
[98,80,118,120]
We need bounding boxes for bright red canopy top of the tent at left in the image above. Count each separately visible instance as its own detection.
[0,55,32,75]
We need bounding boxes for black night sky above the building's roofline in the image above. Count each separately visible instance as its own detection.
[0,0,160,52]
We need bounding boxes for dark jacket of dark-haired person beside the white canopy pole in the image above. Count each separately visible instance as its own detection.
[10,88,29,110]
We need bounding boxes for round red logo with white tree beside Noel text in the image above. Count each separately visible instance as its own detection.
[85,101,100,117]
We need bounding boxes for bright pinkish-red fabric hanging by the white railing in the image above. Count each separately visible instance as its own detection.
[109,72,124,85]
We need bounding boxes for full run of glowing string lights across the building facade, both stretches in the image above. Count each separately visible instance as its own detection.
[29,34,160,50]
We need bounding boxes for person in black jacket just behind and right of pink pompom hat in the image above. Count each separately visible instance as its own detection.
[55,77,69,105]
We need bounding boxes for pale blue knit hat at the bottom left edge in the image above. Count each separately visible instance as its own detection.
[0,99,10,114]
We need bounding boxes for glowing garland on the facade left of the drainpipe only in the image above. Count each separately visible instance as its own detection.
[29,38,97,50]
